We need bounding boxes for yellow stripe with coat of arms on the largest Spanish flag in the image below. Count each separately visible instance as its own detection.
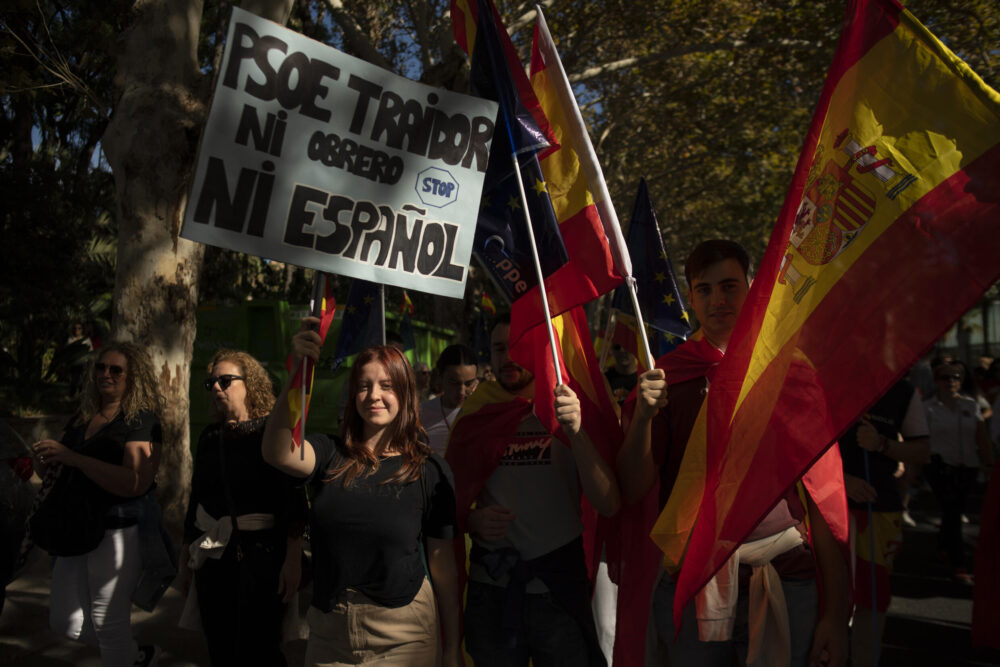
[737,10,1000,418]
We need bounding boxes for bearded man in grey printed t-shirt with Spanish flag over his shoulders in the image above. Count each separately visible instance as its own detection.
[446,320,621,667]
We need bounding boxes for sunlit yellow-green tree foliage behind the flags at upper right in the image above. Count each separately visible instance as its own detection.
[536,0,1000,269]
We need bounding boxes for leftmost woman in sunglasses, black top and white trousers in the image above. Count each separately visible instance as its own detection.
[28,343,162,667]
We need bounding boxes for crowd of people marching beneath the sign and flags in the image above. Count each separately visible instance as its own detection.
[11,240,1000,667]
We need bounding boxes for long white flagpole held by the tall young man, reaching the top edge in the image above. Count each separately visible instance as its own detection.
[535,5,655,368]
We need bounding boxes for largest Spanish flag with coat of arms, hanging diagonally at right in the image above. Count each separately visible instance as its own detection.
[654,0,1000,618]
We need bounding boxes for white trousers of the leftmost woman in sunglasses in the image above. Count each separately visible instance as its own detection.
[49,526,142,667]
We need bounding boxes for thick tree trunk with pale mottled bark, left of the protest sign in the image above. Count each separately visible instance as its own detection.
[103,0,292,527]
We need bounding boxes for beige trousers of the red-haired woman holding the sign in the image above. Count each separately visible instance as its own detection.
[305,578,441,667]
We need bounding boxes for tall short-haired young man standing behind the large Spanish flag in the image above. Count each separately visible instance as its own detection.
[618,240,848,667]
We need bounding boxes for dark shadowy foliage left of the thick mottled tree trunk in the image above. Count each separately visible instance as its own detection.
[0,1,122,406]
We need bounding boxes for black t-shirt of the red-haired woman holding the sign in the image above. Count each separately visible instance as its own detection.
[307,434,456,612]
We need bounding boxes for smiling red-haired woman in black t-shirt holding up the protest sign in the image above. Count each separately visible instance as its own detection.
[264,317,459,666]
